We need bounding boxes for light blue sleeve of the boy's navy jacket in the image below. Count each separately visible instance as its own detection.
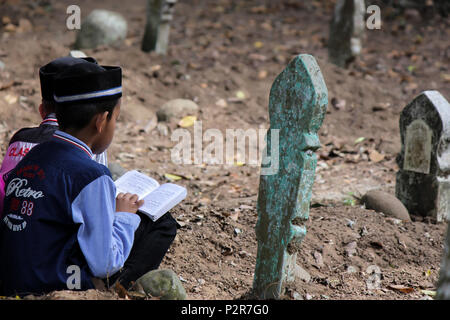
[72,175,141,278]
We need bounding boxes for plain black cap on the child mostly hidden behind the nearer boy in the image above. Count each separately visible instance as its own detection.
[39,56,97,101]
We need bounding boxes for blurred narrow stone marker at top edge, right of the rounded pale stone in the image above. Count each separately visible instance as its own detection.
[142,0,177,54]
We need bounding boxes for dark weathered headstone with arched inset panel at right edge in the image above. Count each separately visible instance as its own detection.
[395,91,450,221]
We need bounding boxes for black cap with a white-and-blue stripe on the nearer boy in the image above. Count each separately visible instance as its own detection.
[54,63,122,104]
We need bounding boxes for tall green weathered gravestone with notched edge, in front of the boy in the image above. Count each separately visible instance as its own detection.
[253,54,328,299]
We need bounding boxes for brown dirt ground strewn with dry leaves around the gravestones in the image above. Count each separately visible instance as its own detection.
[0,0,450,300]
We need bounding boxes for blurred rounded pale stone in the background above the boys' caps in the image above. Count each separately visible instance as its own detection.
[74,9,127,49]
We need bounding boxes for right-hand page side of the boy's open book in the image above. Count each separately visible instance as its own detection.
[139,183,187,221]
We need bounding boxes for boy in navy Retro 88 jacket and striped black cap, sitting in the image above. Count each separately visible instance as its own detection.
[0,63,176,295]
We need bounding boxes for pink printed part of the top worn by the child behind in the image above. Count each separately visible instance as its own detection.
[0,141,37,218]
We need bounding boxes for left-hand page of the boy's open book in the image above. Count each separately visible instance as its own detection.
[114,170,159,199]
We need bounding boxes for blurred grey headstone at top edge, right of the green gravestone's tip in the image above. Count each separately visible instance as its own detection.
[328,0,366,67]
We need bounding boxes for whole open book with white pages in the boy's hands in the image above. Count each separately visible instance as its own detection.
[114,170,187,221]
